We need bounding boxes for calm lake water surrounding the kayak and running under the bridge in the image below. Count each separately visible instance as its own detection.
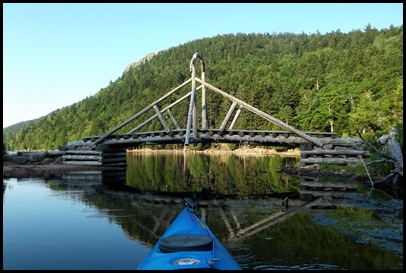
[3,154,403,270]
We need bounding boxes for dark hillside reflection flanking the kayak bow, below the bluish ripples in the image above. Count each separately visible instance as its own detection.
[80,186,401,269]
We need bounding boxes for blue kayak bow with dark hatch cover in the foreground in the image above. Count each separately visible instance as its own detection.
[138,201,242,270]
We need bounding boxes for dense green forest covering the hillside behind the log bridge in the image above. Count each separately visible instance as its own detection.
[3,25,403,150]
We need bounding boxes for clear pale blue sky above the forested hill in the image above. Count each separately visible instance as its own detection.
[3,3,403,128]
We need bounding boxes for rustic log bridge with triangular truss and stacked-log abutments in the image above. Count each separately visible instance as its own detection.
[62,52,369,165]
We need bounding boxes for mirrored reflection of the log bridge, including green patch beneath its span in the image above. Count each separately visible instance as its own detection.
[64,153,364,246]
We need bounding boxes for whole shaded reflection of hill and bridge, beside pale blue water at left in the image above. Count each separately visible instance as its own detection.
[54,154,403,270]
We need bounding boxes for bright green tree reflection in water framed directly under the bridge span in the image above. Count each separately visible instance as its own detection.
[127,153,300,196]
